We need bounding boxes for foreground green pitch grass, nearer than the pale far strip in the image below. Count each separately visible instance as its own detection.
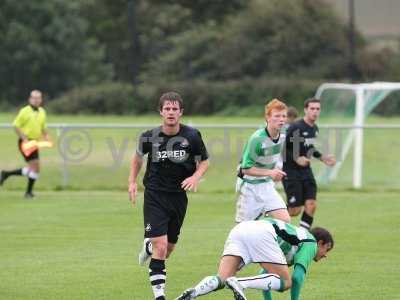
[0,191,400,300]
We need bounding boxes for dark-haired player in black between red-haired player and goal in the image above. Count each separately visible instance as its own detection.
[282,98,336,229]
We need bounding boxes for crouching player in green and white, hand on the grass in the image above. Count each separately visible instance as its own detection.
[176,218,333,300]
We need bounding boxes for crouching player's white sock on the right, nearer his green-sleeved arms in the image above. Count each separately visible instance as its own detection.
[238,274,284,291]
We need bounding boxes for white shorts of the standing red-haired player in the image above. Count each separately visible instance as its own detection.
[235,181,286,223]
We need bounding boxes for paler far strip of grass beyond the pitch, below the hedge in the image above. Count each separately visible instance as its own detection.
[0,113,400,192]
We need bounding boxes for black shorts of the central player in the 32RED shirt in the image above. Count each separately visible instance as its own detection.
[143,189,188,244]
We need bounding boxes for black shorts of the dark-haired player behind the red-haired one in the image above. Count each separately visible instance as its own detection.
[282,178,317,207]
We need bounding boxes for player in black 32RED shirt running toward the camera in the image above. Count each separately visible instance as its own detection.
[129,92,209,300]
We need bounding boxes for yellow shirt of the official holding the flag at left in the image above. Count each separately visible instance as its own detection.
[13,105,46,140]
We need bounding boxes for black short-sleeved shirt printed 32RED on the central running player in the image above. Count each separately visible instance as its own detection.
[137,124,208,192]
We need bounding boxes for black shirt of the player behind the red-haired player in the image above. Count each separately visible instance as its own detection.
[283,119,322,177]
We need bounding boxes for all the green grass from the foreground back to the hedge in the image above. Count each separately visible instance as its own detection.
[0,114,400,300]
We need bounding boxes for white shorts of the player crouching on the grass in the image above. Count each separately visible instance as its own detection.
[222,220,287,267]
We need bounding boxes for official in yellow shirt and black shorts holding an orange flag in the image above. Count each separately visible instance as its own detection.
[0,90,49,199]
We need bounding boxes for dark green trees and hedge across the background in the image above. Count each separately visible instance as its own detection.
[0,0,400,114]
